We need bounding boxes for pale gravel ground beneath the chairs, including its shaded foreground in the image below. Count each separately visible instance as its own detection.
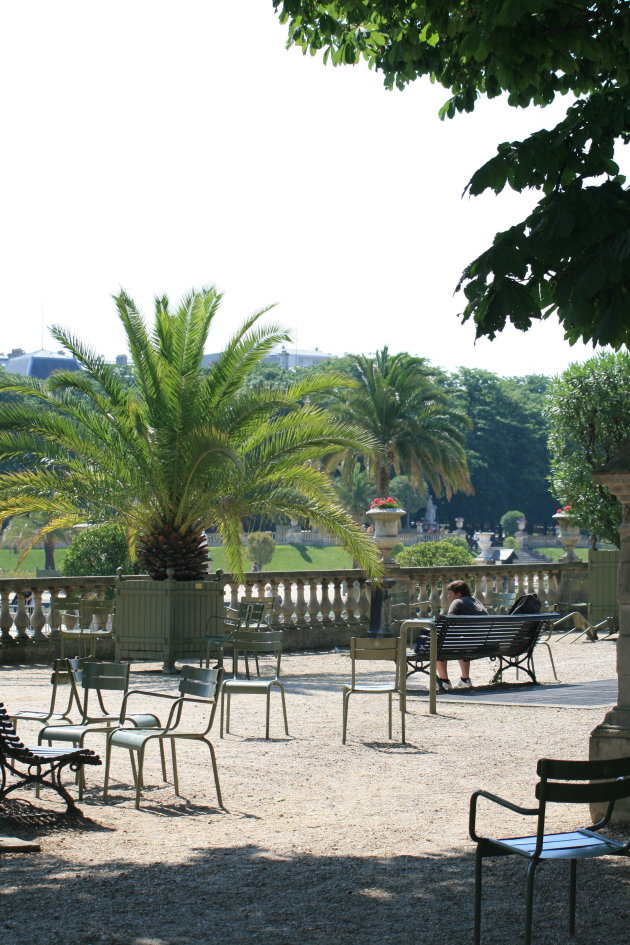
[0,641,630,945]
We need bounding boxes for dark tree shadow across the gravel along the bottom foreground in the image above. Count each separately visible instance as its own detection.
[0,836,630,945]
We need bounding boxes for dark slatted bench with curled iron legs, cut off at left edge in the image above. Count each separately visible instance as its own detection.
[0,702,101,814]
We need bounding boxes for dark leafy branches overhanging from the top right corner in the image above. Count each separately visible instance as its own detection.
[273,0,630,348]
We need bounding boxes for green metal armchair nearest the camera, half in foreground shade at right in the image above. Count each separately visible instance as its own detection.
[469,758,630,945]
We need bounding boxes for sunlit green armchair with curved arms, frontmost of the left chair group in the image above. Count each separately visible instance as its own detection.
[103,666,223,808]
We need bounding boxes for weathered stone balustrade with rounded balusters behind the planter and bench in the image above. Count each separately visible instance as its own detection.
[0,562,587,663]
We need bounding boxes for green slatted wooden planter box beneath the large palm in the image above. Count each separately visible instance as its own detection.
[114,577,225,672]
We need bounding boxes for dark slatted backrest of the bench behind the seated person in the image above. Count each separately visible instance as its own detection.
[435,614,553,659]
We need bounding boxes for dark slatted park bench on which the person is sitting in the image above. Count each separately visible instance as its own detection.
[405,614,558,683]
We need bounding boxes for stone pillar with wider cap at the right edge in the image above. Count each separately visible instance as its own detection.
[589,440,630,823]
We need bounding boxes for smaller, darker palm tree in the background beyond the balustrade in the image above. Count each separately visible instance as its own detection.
[329,347,472,499]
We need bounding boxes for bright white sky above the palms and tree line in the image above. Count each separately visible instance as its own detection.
[0,0,627,376]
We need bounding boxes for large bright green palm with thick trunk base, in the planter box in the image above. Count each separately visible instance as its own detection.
[0,288,380,580]
